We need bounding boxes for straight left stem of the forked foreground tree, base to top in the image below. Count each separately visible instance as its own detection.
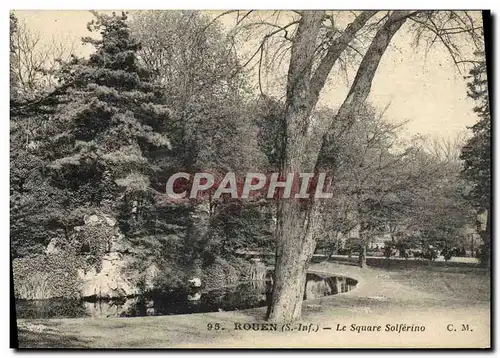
[267,11,324,322]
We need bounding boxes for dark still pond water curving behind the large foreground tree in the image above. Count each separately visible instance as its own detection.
[16,273,357,318]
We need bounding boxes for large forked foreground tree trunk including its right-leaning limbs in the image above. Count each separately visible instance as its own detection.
[268,11,409,322]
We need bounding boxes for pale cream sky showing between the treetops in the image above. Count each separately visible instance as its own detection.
[16,10,484,139]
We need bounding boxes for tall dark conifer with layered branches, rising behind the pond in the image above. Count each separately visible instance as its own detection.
[49,13,169,215]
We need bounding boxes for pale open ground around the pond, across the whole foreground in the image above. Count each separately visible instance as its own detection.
[13,262,490,348]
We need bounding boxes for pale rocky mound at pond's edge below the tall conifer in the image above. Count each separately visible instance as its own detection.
[78,252,139,298]
